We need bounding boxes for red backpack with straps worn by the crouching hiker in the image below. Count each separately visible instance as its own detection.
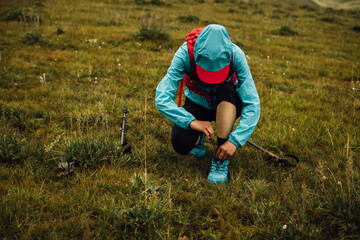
[178,28,237,107]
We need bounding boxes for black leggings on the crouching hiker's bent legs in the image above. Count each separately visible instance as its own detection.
[171,82,242,155]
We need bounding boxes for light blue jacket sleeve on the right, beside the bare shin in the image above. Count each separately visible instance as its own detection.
[229,46,260,148]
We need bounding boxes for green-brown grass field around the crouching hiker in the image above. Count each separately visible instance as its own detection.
[0,0,360,240]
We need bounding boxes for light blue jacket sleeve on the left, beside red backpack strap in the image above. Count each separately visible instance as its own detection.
[155,42,195,129]
